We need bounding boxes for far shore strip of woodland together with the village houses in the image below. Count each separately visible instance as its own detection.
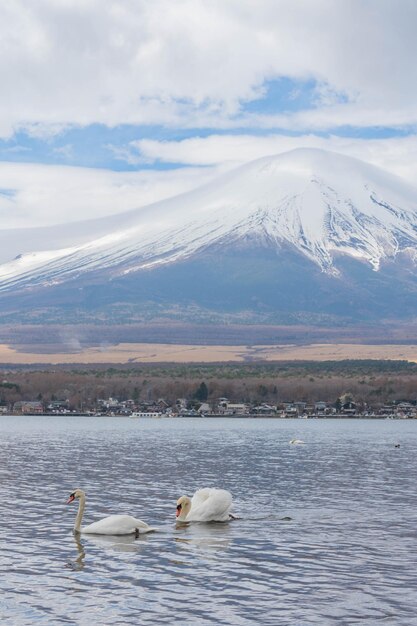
[0,359,417,417]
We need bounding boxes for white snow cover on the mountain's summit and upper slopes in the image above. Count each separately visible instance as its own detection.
[0,149,417,290]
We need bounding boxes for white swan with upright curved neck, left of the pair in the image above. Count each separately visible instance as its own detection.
[67,489,155,535]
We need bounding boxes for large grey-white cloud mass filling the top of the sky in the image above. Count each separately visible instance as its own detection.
[0,0,417,136]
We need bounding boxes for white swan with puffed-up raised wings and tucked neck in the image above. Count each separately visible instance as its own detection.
[176,487,236,522]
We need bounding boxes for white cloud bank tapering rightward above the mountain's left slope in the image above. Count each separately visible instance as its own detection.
[0,163,219,229]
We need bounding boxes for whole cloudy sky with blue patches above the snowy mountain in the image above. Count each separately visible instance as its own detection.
[0,0,417,228]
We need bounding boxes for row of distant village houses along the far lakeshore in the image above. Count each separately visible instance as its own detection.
[4,394,417,419]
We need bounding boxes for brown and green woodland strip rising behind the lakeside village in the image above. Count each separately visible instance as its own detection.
[0,361,417,409]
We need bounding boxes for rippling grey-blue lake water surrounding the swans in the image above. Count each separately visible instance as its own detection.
[0,416,417,626]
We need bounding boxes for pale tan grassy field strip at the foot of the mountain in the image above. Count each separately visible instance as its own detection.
[0,343,417,365]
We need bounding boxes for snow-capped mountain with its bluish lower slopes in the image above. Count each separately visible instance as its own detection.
[0,148,417,319]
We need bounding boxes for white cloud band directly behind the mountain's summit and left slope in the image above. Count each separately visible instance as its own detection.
[0,135,417,229]
